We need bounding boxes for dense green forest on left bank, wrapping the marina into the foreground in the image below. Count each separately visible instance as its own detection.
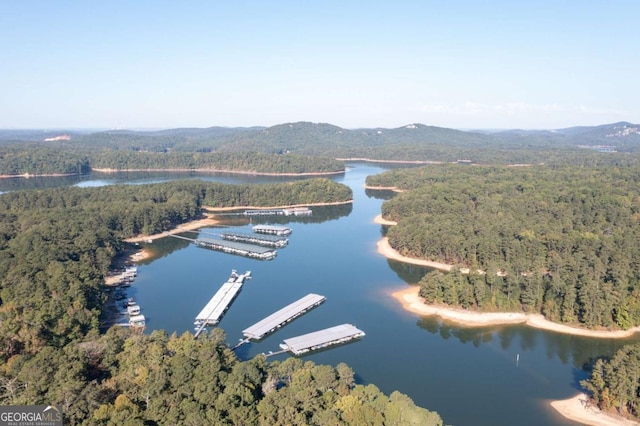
[0,179,441,425]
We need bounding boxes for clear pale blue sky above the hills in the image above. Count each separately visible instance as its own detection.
[0,0,640,129]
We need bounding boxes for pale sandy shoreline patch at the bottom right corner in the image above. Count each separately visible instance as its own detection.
[549,393,640,426]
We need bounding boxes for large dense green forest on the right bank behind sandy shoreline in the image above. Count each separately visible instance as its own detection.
[367,165,640,329]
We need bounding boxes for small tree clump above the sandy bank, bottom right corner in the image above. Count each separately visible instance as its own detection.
[580,344,640,418]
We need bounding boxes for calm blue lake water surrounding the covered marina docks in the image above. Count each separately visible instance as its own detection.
[7,164,638,426]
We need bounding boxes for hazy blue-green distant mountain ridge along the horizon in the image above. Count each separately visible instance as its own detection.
[0,121,640,163]
